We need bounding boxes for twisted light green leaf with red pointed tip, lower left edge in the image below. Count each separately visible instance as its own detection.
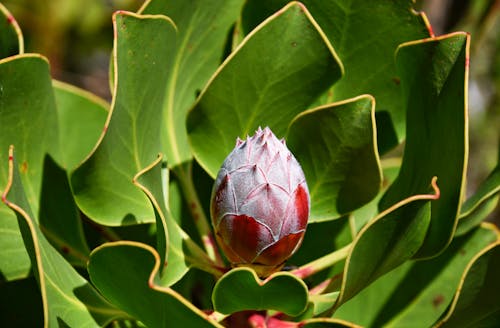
[2,147,124,327]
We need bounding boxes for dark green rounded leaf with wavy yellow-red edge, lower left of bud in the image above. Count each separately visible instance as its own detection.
[88,241,218,327]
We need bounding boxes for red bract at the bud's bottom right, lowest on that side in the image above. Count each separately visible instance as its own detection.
[255,231,304,266]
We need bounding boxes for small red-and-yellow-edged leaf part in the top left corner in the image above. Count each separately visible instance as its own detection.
[0,3,24,58]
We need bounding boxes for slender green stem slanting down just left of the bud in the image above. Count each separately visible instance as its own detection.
[174,162,223,266]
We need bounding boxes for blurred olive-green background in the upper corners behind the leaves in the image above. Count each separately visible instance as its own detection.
[2,0,500,223]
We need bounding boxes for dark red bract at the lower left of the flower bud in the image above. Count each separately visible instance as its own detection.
[218,215,274,263]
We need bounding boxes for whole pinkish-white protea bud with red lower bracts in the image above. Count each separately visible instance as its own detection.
[211,127,310,277]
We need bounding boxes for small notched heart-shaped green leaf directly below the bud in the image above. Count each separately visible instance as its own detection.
[212,267,308,316]
